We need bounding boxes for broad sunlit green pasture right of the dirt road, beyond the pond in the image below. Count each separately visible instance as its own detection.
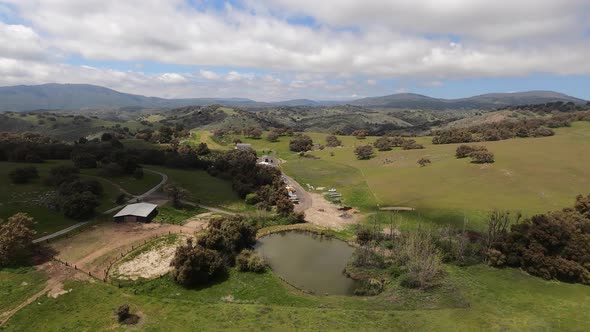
[200,122,590,228]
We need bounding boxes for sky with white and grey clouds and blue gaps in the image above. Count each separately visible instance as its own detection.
[0,0,590,101]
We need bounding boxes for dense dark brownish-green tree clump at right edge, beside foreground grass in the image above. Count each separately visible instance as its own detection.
[486,195,590,284]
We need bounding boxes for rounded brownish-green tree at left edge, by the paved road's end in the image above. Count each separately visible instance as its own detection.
[0,213,35,268]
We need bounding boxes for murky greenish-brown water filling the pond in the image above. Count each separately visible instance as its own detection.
[256,232,355,295]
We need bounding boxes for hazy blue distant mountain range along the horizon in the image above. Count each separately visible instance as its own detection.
[0,84,586,111]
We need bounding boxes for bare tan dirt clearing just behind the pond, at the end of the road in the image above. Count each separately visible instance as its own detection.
[305,193,360,229]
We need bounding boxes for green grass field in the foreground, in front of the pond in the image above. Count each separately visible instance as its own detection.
[1,260,590,331]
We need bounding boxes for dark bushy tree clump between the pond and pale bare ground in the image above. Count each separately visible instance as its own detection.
[170,216,264,287]
